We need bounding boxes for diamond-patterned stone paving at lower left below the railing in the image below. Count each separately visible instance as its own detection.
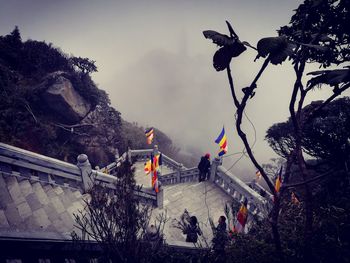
[0,171,85,239]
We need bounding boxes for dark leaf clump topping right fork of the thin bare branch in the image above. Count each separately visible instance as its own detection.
[257,36,295,65]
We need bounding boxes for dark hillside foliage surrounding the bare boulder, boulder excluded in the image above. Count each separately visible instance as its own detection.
[0,27,121,164]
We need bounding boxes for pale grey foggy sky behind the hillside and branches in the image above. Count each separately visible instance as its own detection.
[0,0,349,178]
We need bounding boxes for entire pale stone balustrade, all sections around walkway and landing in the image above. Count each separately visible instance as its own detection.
[0,143,270,217]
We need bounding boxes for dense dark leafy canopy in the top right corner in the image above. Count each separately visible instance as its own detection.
[279,0,350,67]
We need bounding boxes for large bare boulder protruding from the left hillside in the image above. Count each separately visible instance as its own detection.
[42,72,91,124]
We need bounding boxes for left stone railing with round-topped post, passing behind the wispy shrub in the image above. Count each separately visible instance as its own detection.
[0,143,163,207]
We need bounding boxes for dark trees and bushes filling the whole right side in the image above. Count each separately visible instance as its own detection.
[204,0,350,262]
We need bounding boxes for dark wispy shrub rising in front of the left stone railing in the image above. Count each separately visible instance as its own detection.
[74,161,164,262]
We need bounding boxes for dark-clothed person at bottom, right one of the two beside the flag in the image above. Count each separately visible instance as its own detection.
[212,216,228,262]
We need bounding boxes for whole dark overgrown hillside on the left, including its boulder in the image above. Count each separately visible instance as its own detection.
[0,27,197,166]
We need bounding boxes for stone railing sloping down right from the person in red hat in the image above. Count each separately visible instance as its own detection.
[210,159,270,217]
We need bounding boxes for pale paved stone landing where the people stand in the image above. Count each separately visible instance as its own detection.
[134,162,232,245]
